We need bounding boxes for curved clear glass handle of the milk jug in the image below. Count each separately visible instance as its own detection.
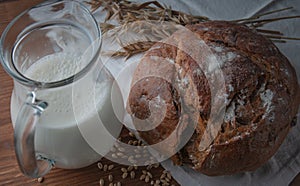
[14,92,54,178]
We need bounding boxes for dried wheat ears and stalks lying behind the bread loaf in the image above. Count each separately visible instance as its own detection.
[86,0,300,59]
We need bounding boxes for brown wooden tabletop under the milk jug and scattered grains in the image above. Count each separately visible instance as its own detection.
[0,0,300,186]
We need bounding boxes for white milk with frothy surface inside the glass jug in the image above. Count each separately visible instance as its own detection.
[11,53,121,168]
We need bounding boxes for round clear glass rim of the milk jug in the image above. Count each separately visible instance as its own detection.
[0,0,102,89]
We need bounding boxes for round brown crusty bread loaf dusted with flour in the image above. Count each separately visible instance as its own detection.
[129,21,300,176]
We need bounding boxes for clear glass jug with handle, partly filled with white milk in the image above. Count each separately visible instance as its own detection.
[0,1,121,177]
